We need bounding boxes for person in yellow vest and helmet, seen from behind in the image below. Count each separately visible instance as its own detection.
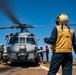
[44,13,76,75]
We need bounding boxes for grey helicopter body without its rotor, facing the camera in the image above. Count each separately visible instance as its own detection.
[6,32,38,62]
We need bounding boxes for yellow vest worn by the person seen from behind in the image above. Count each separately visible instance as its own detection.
[51,26,74,53]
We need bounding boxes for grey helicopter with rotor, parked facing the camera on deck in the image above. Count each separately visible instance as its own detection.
[0,0,46,63]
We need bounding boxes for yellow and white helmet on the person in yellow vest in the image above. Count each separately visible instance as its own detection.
[56,13,69,25]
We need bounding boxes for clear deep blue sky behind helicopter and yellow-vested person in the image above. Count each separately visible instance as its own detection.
[0,0,76,57]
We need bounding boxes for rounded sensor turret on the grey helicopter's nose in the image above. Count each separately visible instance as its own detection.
[18,46,27,60]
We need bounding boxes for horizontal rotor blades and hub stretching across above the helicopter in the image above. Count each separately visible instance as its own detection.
[0,24,76,29]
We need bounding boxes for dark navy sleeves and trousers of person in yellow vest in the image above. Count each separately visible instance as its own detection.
[44,27,76,75]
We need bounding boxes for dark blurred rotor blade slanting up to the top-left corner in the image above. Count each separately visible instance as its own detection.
[0,0,21,24]
